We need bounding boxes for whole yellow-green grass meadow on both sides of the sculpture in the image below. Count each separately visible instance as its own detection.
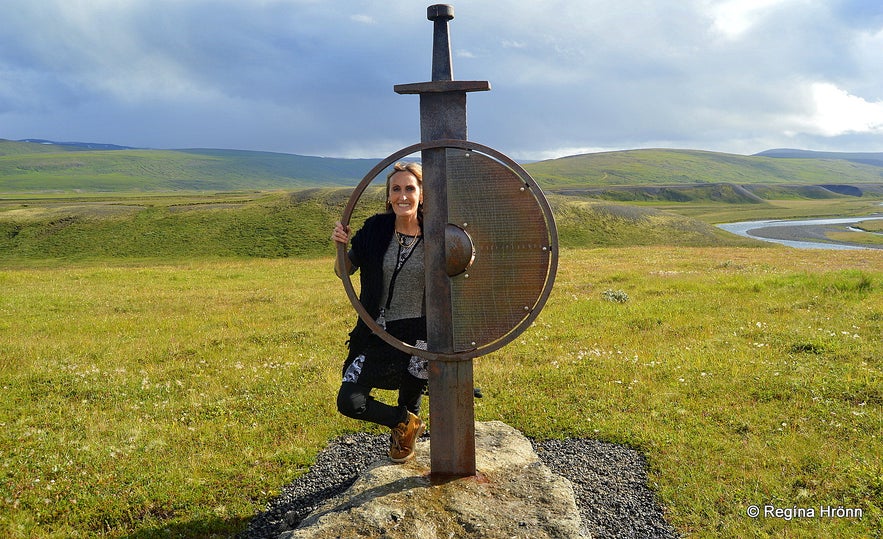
[0,246,883,538]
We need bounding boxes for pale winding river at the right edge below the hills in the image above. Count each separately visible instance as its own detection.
[717,216,883,249]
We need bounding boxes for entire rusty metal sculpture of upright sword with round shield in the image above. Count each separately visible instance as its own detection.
[337,4,558,478]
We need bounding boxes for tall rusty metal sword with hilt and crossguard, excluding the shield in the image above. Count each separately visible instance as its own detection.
[408,5,490,476]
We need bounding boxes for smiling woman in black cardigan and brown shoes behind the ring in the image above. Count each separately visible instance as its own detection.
[331,163,427,462]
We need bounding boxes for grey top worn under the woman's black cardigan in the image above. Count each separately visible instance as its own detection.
[380,233,426,321]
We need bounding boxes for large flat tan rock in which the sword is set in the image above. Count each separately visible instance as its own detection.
[279,421,588,539]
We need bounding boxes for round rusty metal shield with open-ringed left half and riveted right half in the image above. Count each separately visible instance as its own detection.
[338,139,559,361]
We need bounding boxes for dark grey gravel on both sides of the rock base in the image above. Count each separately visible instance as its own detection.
[240,433,678,539]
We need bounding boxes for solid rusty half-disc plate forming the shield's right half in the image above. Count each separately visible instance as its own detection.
[448,144,558,355]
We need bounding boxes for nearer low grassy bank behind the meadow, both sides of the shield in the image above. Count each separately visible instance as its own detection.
[0,188,756,264]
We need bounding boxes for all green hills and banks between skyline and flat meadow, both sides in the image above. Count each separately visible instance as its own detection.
[6,141,883,264]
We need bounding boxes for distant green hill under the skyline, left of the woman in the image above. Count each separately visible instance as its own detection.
[0,140,376,193]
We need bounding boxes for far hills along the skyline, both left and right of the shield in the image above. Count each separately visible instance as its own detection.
[0,140,883,194]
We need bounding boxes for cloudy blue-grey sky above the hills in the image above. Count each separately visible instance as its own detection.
[0,0,883,159]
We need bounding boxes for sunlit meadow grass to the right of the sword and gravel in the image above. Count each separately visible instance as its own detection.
[477,249,883,537]
